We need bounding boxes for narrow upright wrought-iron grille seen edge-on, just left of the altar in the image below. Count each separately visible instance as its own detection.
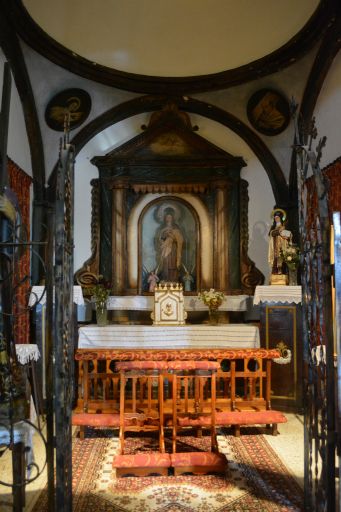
[49,133,75,512]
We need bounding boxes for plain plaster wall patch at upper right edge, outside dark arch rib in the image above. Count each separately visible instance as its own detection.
[314,51,341,167]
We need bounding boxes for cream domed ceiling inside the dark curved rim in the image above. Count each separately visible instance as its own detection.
[23,0,319,77]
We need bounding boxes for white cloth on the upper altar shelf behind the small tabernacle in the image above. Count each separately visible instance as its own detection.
[107,295,249,311]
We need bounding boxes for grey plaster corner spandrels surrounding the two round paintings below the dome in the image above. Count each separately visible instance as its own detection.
[21,42,317,184]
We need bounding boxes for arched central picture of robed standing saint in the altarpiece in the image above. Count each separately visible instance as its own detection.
[139,197,199,293]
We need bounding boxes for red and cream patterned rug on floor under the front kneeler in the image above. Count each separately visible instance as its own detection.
[34,428,303,512]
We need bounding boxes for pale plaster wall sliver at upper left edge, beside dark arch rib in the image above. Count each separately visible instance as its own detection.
[0,49,32,176]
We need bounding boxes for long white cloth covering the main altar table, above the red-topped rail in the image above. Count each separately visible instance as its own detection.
[78,324,260,350]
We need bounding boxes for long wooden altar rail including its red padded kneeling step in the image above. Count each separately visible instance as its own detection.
[73,348,286,435]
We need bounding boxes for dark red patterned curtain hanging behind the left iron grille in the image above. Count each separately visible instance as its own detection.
[8,158,32,343]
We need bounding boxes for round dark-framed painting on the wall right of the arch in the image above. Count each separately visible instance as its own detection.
[247,89,290,136]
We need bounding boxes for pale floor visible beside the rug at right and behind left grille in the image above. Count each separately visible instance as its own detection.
[0,414,304,512]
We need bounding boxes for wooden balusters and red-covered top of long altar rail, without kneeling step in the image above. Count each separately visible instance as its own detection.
[75,349,279,413]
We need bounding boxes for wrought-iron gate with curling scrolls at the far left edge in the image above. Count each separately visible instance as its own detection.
[0,181,47,512]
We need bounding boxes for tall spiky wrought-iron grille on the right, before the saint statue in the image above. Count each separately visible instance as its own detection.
[293,104,336,511]
